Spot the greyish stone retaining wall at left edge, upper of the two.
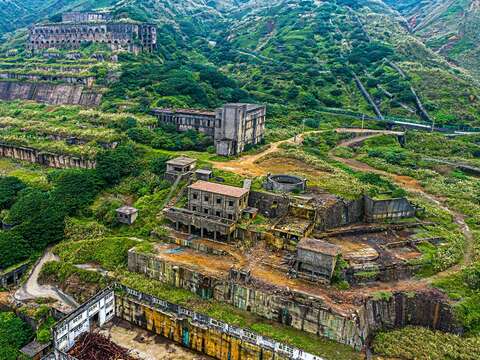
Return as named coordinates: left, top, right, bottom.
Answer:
left=0, top=80, right=102, bottom=107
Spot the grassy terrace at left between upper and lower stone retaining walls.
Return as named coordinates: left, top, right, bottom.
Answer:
left=0, top=101, right=156, bottom=158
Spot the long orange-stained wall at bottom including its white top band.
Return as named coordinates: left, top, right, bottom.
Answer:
left=115, top=287, right=322, bottom=360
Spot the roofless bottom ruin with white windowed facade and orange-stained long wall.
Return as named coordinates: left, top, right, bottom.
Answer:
left=46, top=284, right=322, bottom=360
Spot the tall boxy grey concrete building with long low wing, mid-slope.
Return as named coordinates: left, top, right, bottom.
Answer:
left=152, top=104, right=266, bottom=156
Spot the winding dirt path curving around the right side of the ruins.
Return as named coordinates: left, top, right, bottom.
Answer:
left=329, top=134, right=475, bottom=268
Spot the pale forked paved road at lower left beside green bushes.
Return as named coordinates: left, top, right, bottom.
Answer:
left=14, top=249, right=79, bottom=310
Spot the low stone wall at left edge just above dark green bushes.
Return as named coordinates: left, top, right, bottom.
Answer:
left=0, top=143, right=96, bottom=169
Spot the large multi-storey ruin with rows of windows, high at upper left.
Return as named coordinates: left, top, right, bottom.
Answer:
left=27, top=13, right=157, bottom=54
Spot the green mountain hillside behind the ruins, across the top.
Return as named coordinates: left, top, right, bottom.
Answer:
left=0, top=0, right=479, bottom=126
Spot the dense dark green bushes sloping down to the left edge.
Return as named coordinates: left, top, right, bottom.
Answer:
left=0, top=145, right=141, bottom=268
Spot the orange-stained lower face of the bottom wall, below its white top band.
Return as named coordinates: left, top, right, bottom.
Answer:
left=115, top=295, right=287, bottom=360
